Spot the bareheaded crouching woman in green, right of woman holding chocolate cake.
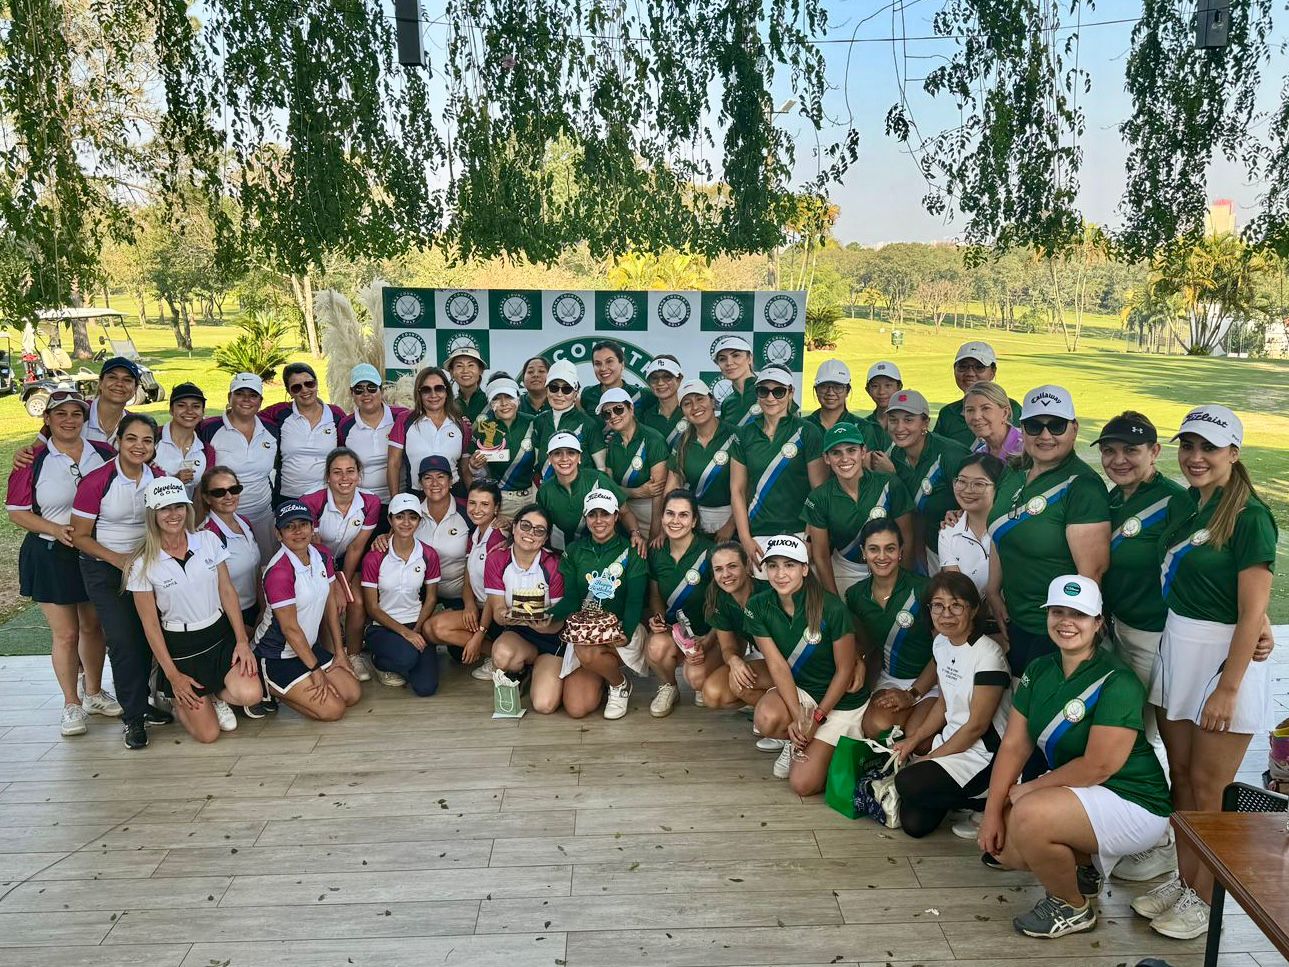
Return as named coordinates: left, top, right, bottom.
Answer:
left=645, top=490, right=721, bottom=718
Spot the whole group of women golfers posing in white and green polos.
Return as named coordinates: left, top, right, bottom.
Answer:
left=6, top=335, right=1276, bottom=937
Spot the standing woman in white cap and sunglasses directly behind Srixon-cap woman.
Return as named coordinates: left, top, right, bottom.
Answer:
left=730, top=366, right=828, bottom=565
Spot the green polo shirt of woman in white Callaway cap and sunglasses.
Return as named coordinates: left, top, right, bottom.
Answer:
left=989, top=453, right=1110, bottom=637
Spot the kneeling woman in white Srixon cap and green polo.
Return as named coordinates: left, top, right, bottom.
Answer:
left=746, top=534, right=867, bottom=796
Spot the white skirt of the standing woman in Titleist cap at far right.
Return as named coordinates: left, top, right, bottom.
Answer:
left=1150, top=611, right=1272, bottom=735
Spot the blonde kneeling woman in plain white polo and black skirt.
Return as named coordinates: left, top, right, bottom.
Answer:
left=125, top=477, right=260, bottom=743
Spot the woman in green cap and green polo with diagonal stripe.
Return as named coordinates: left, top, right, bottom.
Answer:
left=806, top=423, right=913, bottom=597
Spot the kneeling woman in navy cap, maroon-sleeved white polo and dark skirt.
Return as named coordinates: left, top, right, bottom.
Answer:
left=255, top=500, right=362, bottom=722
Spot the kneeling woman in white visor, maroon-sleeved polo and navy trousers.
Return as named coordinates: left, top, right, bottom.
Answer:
left=362, top=494, right=440, bottom=698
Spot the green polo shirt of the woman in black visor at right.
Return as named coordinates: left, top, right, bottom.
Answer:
left=1101, top=472, right=1186, bottom=632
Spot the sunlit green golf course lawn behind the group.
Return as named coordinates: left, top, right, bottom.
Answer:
left=0, top=318, right=1289, bottom=654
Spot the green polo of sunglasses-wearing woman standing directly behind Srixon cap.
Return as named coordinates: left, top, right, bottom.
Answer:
left=730, top=416, right=824, bottom=536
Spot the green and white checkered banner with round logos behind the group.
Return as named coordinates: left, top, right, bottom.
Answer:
left=384, top=286, right=806, bottom=400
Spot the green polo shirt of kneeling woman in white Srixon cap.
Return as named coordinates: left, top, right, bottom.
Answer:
left=745, top=589, right=869, bottom=712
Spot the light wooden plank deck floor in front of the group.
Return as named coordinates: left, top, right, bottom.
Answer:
left=0, top=636, right=1289, bottom=967
